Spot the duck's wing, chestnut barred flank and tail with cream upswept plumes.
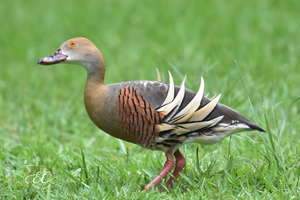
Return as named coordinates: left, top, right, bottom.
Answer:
left=110, top=74, right=265, bottom=151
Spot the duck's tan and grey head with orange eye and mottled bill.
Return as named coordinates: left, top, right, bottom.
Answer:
left=38, top=37, right=105, bottom=71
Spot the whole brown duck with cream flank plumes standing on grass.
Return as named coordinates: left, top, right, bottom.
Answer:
left=38, top=37, right=266, bottom=192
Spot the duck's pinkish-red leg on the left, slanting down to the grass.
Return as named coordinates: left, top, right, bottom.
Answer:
left=142, top=151, right=176, bottom=192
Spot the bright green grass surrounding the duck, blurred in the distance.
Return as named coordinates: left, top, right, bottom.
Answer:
left=0, top=0, right=300, bottom=199
